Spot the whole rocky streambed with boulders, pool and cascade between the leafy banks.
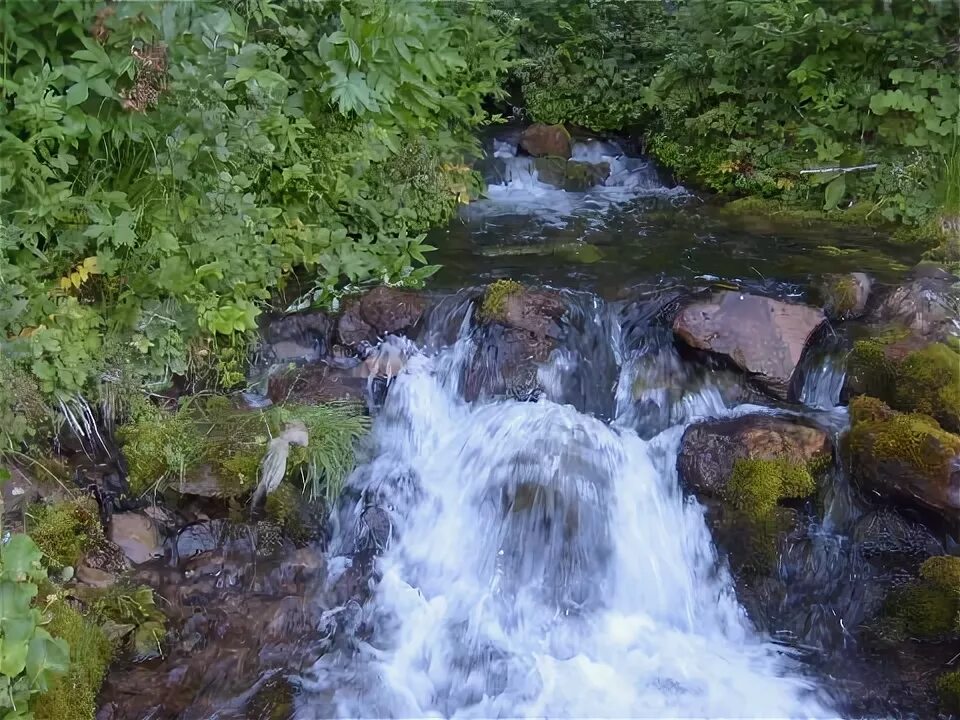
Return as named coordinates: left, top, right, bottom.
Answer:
left=4, top=126, right=960, bottom=720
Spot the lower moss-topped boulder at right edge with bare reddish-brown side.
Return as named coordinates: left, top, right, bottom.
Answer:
left=848, top=396, right=960, bottom=521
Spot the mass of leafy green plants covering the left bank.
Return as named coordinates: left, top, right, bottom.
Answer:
left=0, top=0, right=514, bottom=442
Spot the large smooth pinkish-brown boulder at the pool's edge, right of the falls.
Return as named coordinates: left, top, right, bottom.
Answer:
left=673, top=292, right=826, bottom=400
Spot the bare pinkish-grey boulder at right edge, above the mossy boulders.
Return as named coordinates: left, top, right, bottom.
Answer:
left=870, top=273, right=960, bottom=339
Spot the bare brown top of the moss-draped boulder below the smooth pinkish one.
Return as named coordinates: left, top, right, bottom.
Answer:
left=677, top=415, right=832, bottom=497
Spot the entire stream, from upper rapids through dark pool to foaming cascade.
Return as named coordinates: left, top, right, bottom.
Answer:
left=97, top=132, right=952, bottom=720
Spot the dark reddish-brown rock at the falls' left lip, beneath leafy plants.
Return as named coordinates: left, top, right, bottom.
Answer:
left=337, top=287, right=429, bottom=346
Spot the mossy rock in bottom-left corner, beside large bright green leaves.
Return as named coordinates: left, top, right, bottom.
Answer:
left=31, top=599, right=112, bottom=720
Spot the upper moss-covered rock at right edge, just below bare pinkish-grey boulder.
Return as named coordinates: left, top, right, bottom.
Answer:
left=850, top=335, right=960, bottom=432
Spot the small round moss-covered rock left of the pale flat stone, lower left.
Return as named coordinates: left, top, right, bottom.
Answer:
left=27, top=495, right=106, bottom=570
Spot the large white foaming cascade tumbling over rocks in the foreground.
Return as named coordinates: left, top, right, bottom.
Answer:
left=296, top=300, right=829, bottom=720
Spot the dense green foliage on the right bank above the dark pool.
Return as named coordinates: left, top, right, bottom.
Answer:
left=499, top=0, right=960, bottom=227
